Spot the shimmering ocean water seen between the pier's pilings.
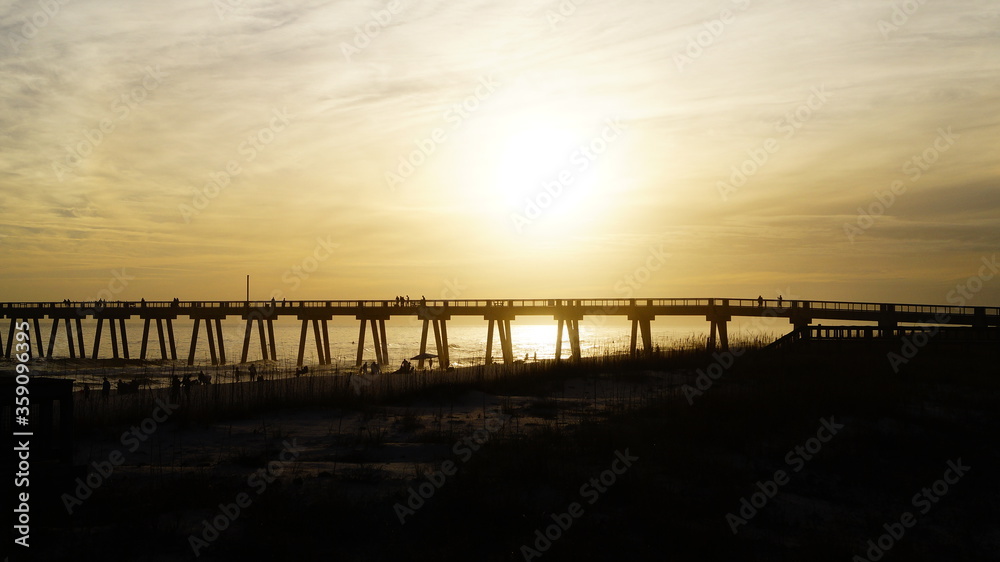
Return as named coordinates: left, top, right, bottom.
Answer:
left=2, top=318, right=708, bottom=367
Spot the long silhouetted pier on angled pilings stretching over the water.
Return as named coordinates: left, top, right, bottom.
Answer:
left=0, top=298, right=1000, bottom=368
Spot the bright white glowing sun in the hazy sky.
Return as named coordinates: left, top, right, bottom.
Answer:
left=452, top=101, right=628, bottom=241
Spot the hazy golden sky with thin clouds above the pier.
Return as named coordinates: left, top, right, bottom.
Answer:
left=0, top=0, right=1000, bottom=306
